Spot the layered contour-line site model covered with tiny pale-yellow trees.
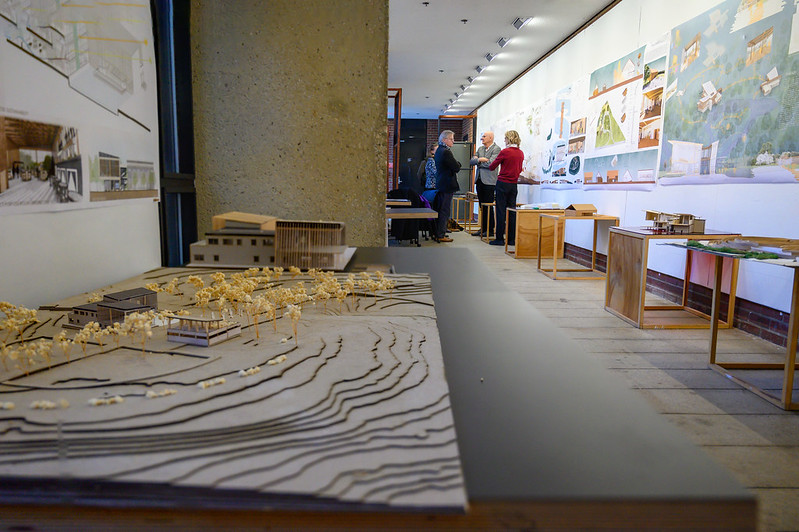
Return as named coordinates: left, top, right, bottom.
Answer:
left=0, top=267, right=467, bottom=512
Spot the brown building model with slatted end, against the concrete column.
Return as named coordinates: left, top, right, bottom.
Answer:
left=189, top=212, right=355, bottom=270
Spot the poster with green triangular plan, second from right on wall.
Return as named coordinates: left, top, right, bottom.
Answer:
left=583, top=35, right=668, bottom=190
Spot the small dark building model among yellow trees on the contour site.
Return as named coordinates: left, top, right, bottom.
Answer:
left=64, top=288, right=158, bottom=329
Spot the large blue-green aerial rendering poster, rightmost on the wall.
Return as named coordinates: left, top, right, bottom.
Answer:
left=658, top=0, right=799, bottom=185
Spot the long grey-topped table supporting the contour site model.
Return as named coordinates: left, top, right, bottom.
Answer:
left=0, top=247, right=756, bottom=530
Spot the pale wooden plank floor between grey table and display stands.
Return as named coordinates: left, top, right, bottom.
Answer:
left=389, top=232, right=799, bottom=531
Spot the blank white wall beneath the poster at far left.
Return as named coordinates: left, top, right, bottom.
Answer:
left=0, top=202, right=161, bottom=308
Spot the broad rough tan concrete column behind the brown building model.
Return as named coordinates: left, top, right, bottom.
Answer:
left=191, top=0, right=388, bottom=246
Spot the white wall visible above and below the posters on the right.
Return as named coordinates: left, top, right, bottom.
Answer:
left=476, top=0, right=799, bottom=311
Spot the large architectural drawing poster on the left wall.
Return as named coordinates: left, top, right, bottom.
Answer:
left=0, top=0, right=159, bottom=215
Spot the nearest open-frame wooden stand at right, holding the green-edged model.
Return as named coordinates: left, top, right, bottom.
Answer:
left=693, top=248, right=799, bottom=410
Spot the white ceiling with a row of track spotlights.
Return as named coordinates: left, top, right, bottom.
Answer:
left=388, top=0, right=616, bottom=118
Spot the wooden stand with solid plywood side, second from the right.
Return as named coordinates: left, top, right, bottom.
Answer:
left=605, top=227, right=740, bottom=329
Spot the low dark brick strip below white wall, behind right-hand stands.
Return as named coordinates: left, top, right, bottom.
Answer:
left=564, top=243, right=790, bottom=347
